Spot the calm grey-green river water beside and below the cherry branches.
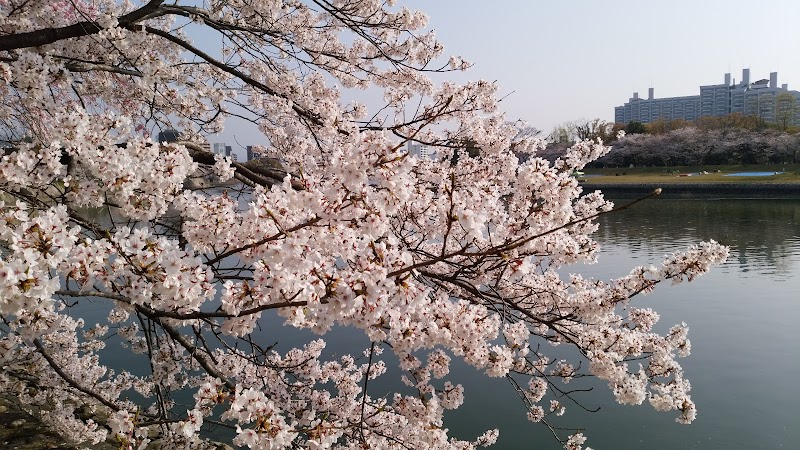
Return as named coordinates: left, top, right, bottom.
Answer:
left=450, top=199, right=800, bottom=450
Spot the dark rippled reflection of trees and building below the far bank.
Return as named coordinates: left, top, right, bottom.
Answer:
left=596, top=199, right=800, bottom=281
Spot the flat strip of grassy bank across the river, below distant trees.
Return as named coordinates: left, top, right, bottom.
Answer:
left=581, top=164, right=800, bottom=185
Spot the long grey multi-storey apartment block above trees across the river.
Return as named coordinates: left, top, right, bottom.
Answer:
left=614, top=69, right=800, bottom=125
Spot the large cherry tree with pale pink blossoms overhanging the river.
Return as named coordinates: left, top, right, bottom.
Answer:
left=0, top=0, right=727, bottom=449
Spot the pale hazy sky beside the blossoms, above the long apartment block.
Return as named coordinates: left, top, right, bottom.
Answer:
left=212, top=0, right=800, bottom=155
